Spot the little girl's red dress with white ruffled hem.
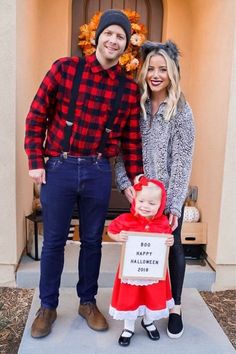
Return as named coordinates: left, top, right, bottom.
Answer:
left=108, top=183, right=174, bottom=320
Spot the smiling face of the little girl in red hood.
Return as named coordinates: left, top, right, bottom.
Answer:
left=135, top=187, right=161, bottom=219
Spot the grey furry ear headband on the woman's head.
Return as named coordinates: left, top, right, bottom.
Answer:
left=141, top=40, right=180, bottom=71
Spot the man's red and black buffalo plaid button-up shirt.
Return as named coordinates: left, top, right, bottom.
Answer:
left=25, top=55, right=143, bottom=183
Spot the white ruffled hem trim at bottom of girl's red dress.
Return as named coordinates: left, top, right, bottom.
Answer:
left=109, top=299, right=175, bottom=321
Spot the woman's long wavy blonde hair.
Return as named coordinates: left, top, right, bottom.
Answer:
left=137, top=49, right=181, bottom=121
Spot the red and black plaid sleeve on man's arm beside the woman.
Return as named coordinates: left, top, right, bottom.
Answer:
left=121, top=84, right=143, bottom=182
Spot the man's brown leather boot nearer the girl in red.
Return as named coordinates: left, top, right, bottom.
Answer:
left=79, top=302, right=108, bottom=331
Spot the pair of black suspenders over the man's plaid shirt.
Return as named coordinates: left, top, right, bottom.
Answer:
left=62, top=58, right=125, bottom=157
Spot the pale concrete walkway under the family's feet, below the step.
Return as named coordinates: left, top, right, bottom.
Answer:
left=18, top=288, right=235, bottom=354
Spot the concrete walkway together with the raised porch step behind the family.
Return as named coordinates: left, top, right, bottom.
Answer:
left=16, top=242, right=235, bottom=354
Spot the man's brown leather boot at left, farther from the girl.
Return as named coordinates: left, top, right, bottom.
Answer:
left=31, top=307, right=57, bottom=338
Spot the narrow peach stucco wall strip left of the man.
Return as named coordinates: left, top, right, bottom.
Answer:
left=16, top=0, right=39, bottom=272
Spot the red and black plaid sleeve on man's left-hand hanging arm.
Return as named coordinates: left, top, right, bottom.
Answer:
left=25, top=60, right=61, bottom=170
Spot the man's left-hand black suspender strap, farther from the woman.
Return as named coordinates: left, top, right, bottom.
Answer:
left=62, top=58, right=85, bottom=152
